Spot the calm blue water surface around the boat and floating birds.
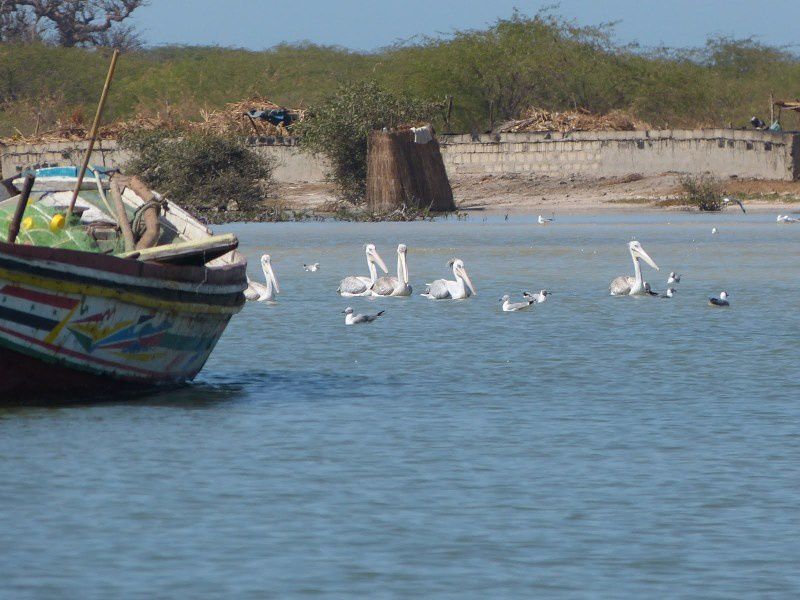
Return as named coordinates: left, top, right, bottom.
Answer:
left=0, top=213, right=800, bottom=599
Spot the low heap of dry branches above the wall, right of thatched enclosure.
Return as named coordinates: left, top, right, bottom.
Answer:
left=495, top=108, right=650, bottom=133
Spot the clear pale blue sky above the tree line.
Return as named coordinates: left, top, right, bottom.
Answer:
left=130, top=0, right=800, bottom=50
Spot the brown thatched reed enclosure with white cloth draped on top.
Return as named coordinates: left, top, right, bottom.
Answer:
left=367, top=129, right=456, bottom=213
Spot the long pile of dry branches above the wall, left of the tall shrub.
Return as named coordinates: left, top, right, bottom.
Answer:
left=0, top=97, right=305, bottom=144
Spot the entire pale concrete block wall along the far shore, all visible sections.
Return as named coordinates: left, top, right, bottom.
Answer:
left=0, top=129, right=800, bottom=183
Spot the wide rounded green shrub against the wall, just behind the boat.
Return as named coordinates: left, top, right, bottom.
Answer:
left=121, top=131, right=273, bottom=213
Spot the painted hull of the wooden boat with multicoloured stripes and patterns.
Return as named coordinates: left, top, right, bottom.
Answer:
left=0, top=243, right=247, bottom=403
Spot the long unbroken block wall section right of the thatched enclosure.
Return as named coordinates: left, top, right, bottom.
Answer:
left=440, top=129, right=800, bottom=180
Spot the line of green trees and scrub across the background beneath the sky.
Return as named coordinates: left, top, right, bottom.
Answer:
left=0, top=10, right=800, bottom=136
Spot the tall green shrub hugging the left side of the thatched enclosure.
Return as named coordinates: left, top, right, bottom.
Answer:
left=295, top=80, right=438, bottom=202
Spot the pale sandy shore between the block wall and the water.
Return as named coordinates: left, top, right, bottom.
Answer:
left=270, top=173, right=800, bottom=215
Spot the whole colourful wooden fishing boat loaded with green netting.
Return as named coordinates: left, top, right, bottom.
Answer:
left=0, top=167, right=247, bottom=401
